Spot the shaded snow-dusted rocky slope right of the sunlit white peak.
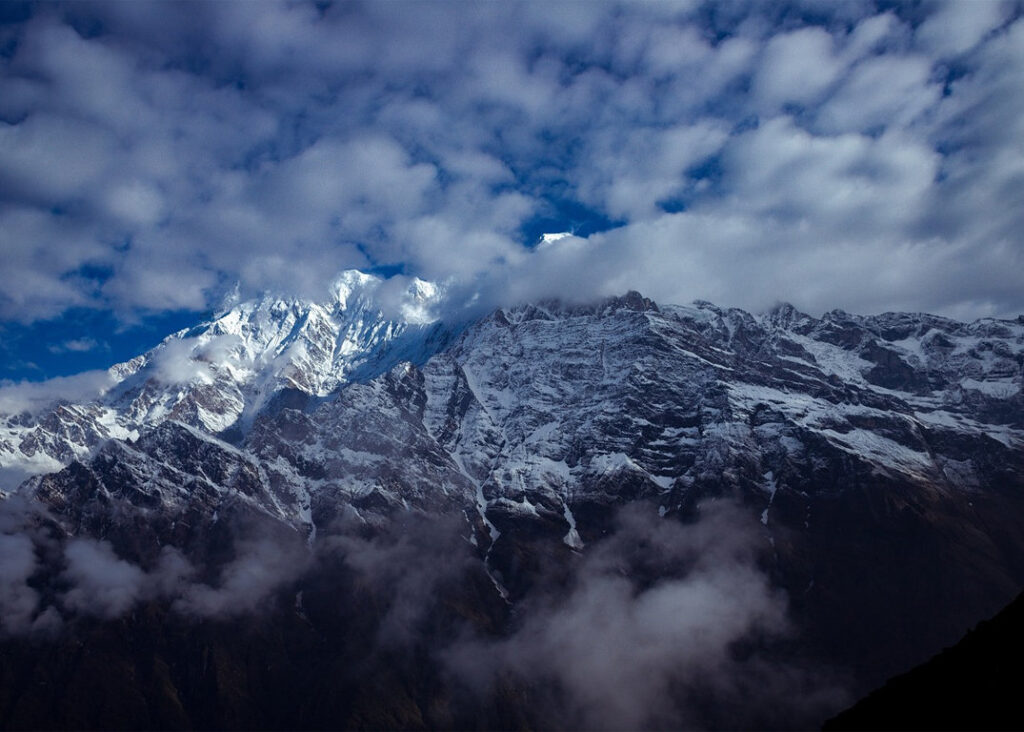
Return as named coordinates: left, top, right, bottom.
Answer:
left=249, top=295, right=1024, bottom=681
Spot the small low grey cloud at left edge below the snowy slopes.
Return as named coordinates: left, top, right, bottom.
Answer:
left=0, top=496, right=311, bottom=636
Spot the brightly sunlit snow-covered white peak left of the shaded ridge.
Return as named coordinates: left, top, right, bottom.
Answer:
left=0, top=269, right=455, bottom=487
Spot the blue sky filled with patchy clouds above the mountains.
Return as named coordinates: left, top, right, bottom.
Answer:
left=0, top=0, right=1024, bottom=381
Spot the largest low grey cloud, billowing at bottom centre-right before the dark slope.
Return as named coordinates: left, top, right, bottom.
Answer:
left=444, top=504, right=841, bottom=729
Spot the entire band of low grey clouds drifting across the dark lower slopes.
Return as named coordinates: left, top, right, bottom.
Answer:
left=0, top=489, right=846, bottom=729
